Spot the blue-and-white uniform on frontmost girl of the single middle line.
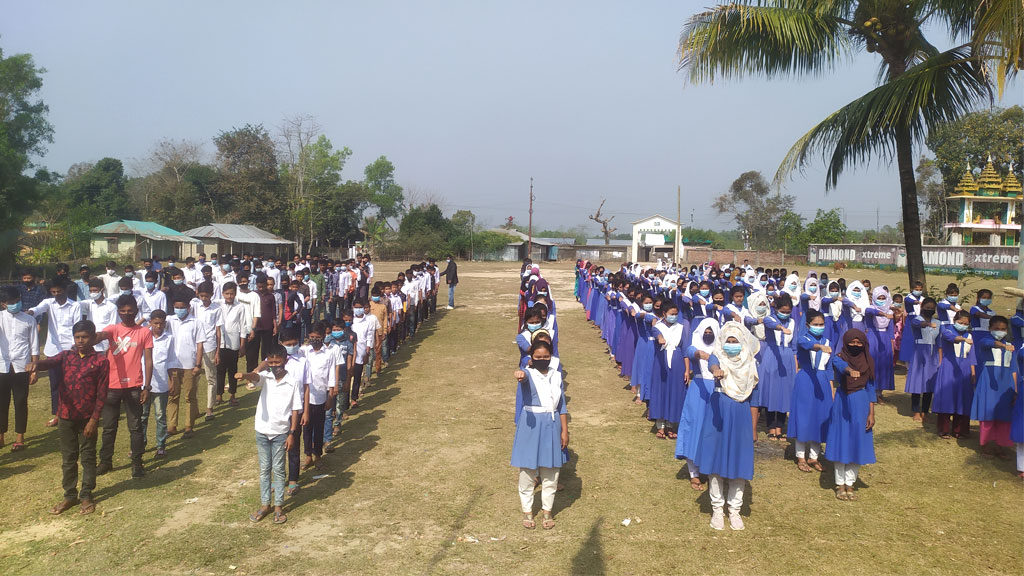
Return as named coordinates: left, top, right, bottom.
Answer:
left=510, top=368, right=568, bottom=469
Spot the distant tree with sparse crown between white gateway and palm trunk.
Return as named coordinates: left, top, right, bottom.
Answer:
left=714, top=171, right=797, bottom=250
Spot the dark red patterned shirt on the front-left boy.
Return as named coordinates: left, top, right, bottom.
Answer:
left=37, top=351, right=110, bottom=420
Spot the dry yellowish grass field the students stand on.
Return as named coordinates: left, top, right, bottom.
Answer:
left=0, top=263, right=1024, bottom=575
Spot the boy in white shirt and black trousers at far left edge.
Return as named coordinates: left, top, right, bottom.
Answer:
left=0, top=287, right=39, bottom=452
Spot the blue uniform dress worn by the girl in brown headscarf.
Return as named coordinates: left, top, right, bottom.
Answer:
left=825, top=356, right=876, bottom=465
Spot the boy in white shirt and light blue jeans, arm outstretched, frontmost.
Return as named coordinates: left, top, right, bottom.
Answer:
left=234, top=344, right=303, bottom=524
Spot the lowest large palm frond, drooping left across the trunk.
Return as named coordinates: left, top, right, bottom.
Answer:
left=775, top=46, right=992, bottom=190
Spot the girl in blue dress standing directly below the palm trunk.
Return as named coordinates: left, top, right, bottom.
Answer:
left=903, top=298, right=939, bottom=423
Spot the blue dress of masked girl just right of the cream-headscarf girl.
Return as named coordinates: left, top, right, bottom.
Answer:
left=758, top=313, right=797, bottom=412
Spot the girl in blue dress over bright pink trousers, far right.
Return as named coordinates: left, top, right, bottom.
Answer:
left=971, top=316, right=1017, bottom=458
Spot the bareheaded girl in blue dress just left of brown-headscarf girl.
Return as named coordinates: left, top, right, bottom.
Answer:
left=786, top=310, right=833, bottom=472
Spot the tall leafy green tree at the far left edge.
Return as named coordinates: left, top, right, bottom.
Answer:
left=0, top=49, right=53, bottom=271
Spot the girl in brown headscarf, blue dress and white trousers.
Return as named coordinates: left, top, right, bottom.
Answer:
left=825, top=328, right=874, bottom=500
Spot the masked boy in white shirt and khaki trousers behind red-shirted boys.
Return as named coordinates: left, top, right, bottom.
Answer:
left=167, top=294, right=206, bottom=438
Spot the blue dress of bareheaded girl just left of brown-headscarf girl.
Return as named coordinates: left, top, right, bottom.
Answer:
left=785, top=330, right=833, bottom=442
